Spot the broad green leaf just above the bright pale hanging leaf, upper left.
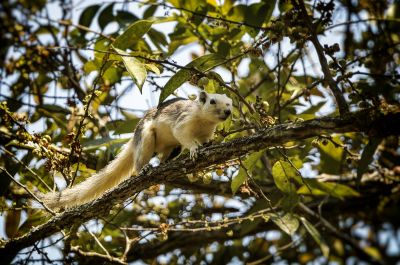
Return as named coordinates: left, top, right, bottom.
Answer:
left=113, top=20, right=153, bottom=50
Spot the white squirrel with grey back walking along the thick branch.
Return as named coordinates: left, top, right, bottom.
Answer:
left=41, top=91, right=232, bottom=209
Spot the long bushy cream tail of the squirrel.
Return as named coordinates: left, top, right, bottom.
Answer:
left=41, top=138, right=136, bottom=209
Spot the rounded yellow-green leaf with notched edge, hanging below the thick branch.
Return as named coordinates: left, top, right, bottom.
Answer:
left=272, top=160, right=298, bottom=193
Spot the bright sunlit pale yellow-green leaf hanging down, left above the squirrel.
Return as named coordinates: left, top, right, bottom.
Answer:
left=113, top=47, right=147, bottom=89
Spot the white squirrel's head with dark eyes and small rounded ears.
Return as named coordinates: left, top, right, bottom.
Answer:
left=199, top=91, right=232, bottom=122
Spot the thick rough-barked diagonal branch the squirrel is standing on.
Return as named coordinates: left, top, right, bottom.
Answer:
left=0, top=111, right=400, bottom=259
